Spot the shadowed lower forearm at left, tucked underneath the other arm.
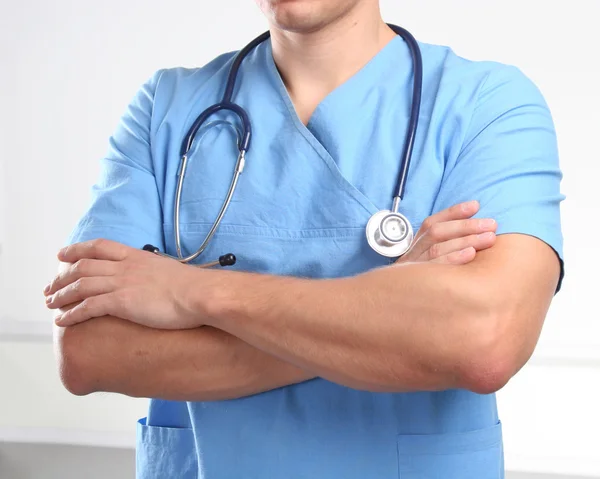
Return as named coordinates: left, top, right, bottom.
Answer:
left=55, top=317, right=313, bottom=401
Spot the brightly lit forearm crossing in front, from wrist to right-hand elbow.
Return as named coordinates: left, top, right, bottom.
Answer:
left=198, top=238, right=554, bottom=393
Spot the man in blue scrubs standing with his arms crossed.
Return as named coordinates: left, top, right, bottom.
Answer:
left=45, top=0, right=562, bottom=479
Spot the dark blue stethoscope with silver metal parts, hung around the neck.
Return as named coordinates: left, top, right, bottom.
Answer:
left=143, top=25, right=423, bottom=268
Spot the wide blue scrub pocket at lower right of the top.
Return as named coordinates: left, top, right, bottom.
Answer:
left=398, top=423, right=504, bottom=479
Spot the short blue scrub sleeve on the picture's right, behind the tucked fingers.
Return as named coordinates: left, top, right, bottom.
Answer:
left=434, top=66, right=564, bottom=288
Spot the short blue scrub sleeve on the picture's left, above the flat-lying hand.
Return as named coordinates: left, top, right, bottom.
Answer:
left=68, top=72, right=164, bottom=250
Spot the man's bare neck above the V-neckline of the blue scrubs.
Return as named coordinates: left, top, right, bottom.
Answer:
left=271, top=3, right=395, bottom=124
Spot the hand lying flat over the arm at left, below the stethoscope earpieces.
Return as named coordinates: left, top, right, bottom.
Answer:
left=44, top=240, right=205, bottom=329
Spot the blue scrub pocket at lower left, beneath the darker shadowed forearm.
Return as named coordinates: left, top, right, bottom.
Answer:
left=136, top=419, right=198, bottom=479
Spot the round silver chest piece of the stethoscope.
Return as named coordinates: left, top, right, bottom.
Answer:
left=366, top=210, right=413, bottom=258
